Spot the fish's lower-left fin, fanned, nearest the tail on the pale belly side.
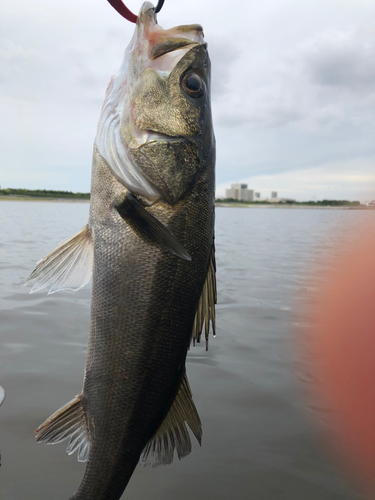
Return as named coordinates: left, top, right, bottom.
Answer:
left=35, top=395, right=90, bottom=462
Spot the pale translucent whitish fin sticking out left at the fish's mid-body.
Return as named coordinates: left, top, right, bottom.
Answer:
left=25, top=225, right=94, bottom=294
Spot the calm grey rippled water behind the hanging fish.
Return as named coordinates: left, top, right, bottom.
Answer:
left=0, top=201, right=374, bottom=500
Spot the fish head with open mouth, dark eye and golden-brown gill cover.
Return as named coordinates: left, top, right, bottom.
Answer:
left=96, top=2, right=215, bottom=204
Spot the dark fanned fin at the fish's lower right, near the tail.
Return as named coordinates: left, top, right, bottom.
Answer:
left=139, top=373, right=202, bottom=467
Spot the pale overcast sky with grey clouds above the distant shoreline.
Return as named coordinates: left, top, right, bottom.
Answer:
left=0, top=0, right=375, bottom=202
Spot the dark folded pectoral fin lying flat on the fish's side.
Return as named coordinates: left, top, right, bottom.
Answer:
left=116, top=194, right=191, bottom=260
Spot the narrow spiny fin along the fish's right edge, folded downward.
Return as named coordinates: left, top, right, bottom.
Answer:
left=191, top=245, right=217, bottom=351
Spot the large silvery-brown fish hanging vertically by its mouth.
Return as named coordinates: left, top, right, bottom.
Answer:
left=28, top=2, right=217, bottom=500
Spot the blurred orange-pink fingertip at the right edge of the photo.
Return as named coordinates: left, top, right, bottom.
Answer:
left=313, top=226, right=375, bottom=498
